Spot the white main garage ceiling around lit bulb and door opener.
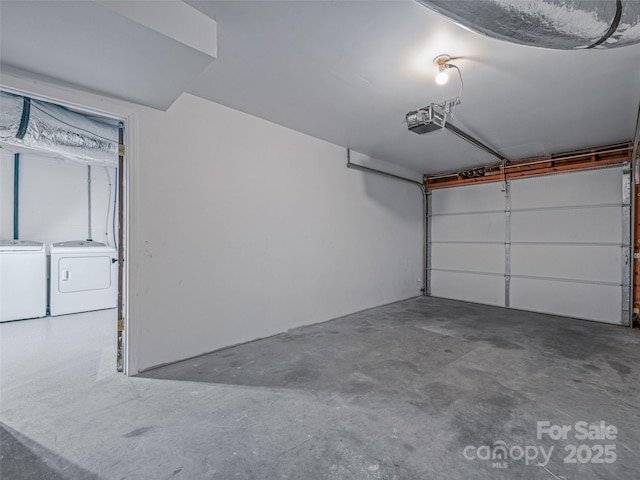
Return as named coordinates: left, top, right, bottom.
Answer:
left=0, top=0, right=640, bottom=173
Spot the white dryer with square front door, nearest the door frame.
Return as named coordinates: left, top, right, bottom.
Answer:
left=49, top=241, right=118, bottom=316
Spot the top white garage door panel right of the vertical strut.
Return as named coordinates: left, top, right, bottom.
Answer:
left=511, top=168, right=622, bottom=209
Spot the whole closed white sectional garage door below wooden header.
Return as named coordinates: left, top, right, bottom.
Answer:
left=428, top=165, right=631, bottom=324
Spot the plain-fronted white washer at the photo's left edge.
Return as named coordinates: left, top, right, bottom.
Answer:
left=0, top=240, right=47, bottom=322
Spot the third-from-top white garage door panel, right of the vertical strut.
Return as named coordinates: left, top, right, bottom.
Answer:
left=511, top=245, right=622, bottom=283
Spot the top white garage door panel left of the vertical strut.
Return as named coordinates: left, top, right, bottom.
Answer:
left=430, top=182, right=504, bottom=215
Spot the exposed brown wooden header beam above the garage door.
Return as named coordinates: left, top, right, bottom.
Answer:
left=424, top=142, right=633, bottom=190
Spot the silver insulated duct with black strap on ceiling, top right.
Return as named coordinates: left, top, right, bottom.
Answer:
left=416, top=0, right=640, bottom=50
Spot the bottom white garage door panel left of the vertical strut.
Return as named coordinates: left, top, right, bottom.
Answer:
left=431, top=270, right=504, bottom=306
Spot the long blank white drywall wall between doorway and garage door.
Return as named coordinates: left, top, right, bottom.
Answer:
left=131, top=94, right=423, bottom=370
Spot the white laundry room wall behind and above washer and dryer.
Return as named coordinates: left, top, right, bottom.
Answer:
left=0, top=149, right=115, bottom=249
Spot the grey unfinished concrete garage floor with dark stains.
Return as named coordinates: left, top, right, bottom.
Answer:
left=1, top=298, right=640, bottom=480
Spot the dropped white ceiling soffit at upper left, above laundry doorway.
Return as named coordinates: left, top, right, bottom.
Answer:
left=0, top=0, right=215, bottom=109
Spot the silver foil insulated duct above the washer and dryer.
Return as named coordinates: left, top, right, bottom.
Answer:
left=0, top=92, right=118, bottom=167
